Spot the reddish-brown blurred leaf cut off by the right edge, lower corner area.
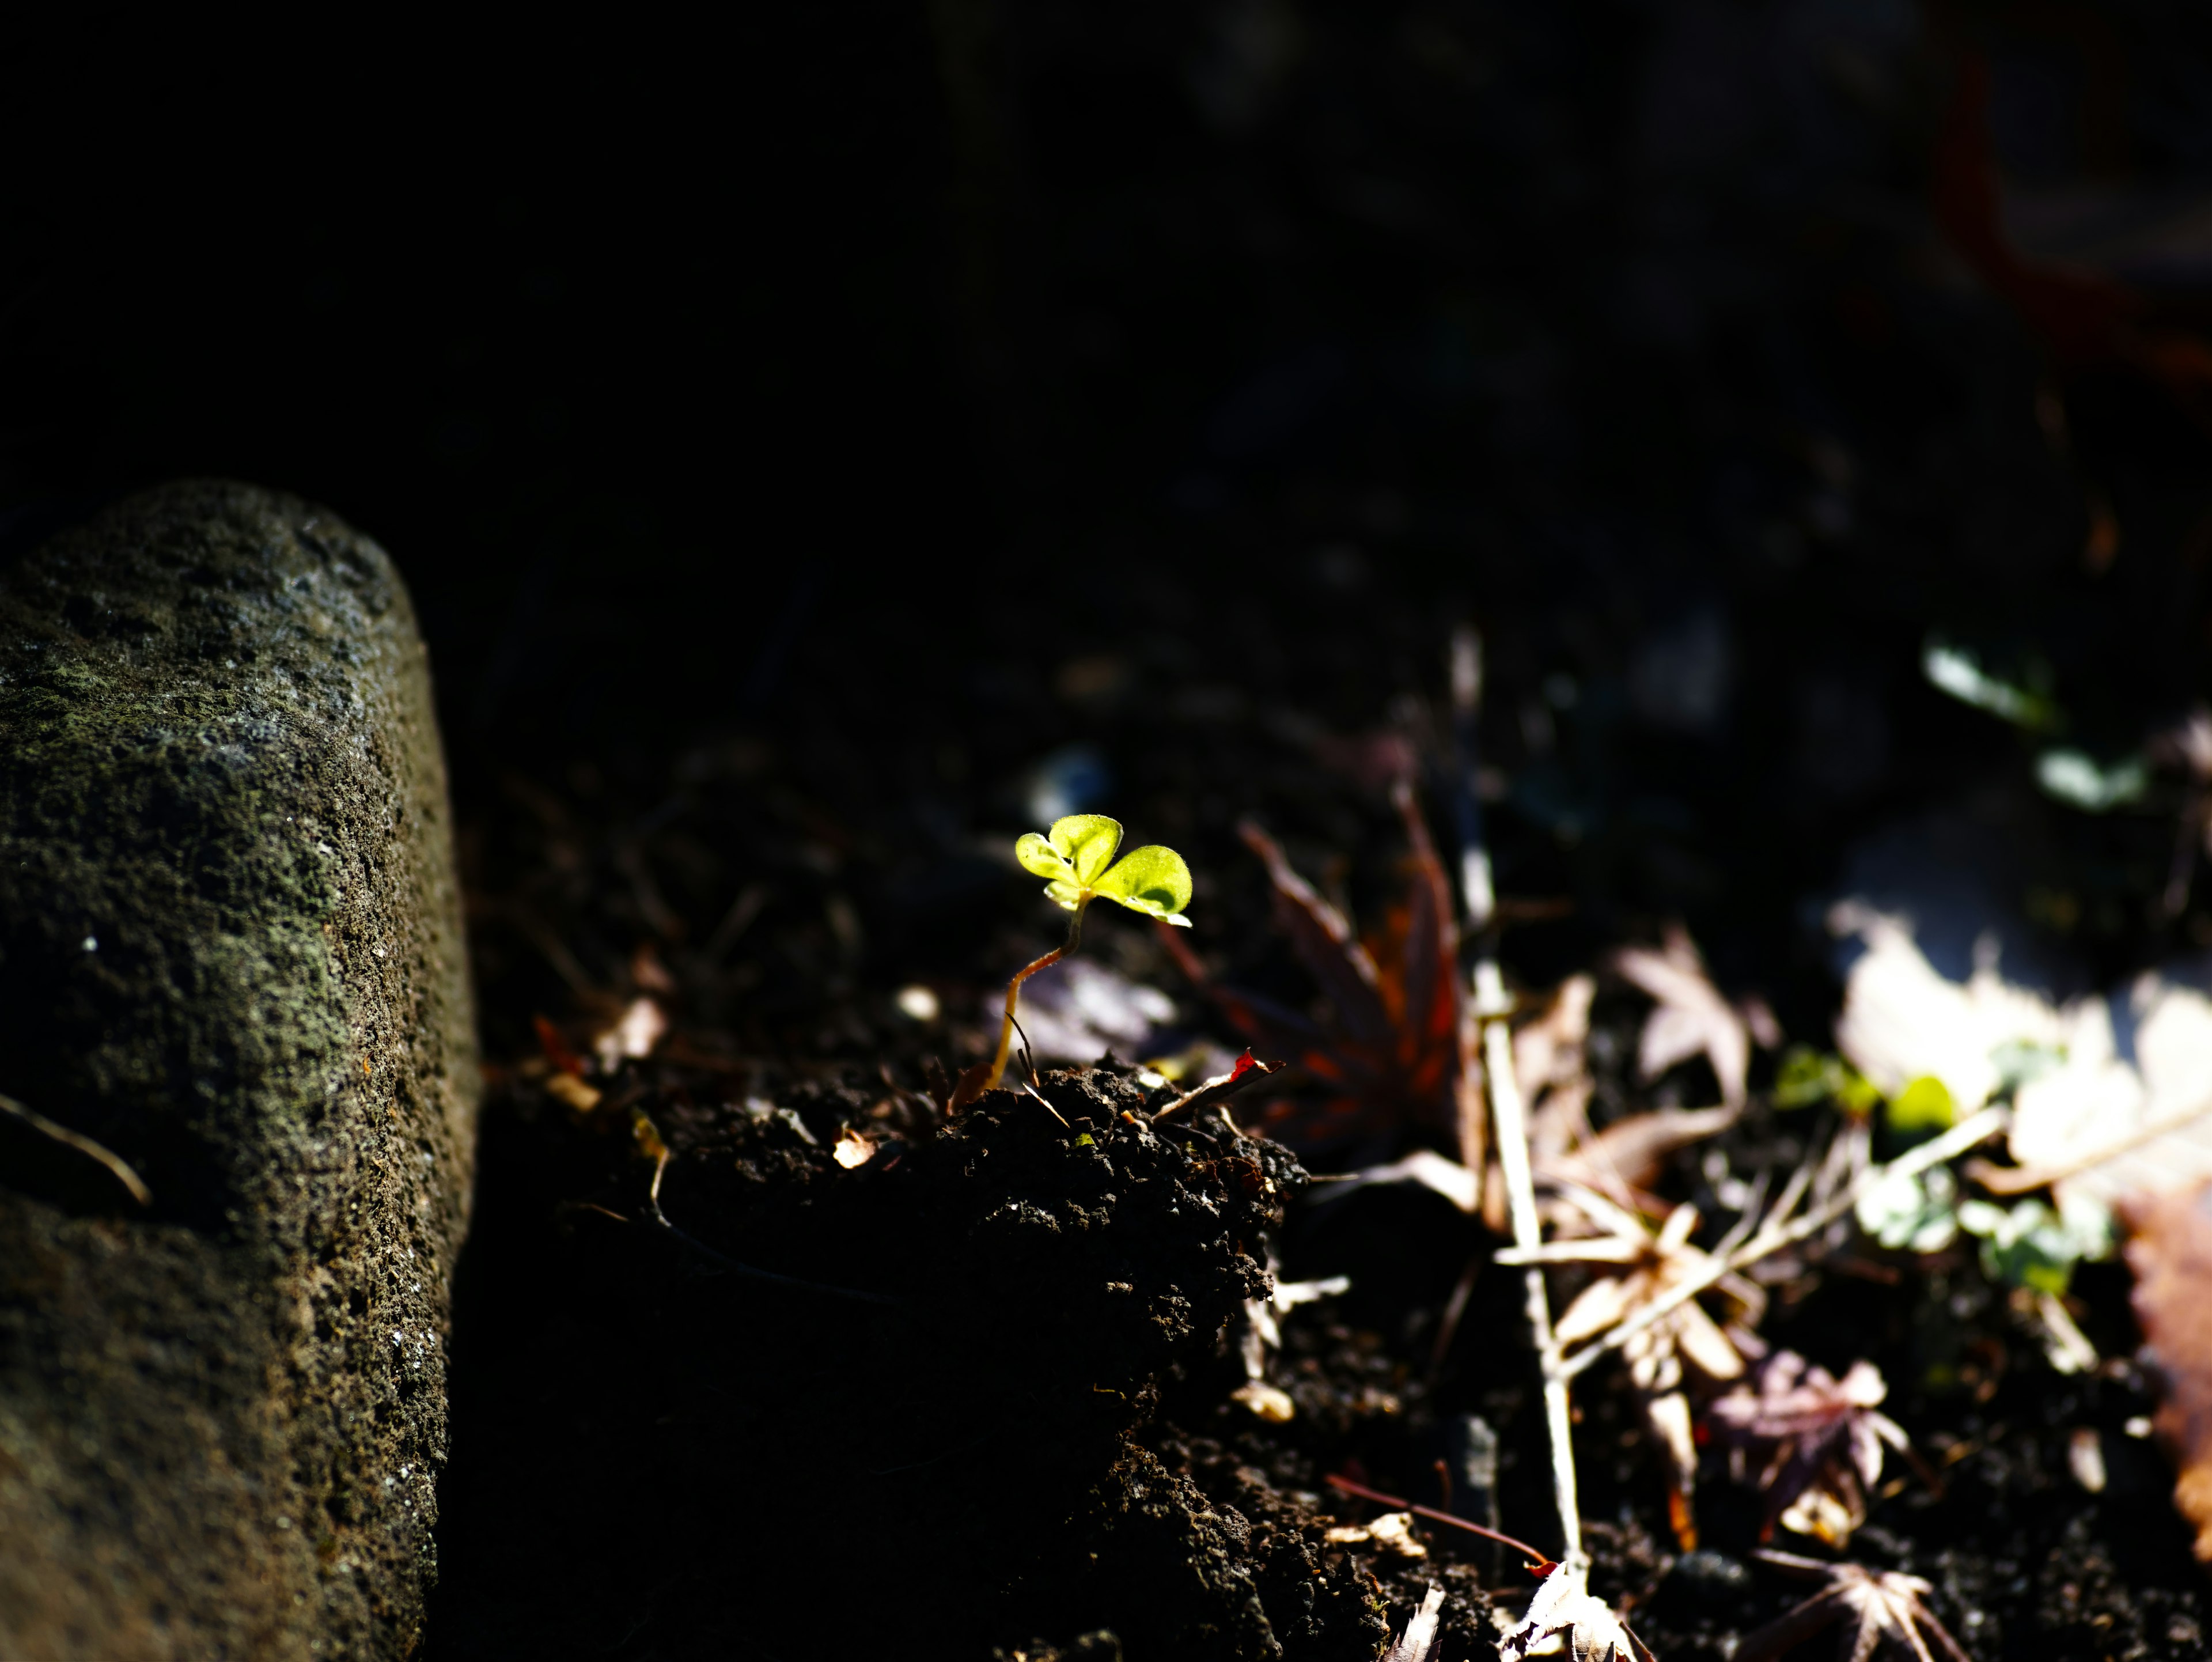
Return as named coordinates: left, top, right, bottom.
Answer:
left=2119, top=1184, right=2212, bottom=1562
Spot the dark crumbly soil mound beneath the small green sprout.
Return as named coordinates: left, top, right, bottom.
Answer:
left=422, top=1065, right=1460, bottom=1662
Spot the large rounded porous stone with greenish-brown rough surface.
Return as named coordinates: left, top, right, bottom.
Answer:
left=0, top=482, right=478, bottom=1662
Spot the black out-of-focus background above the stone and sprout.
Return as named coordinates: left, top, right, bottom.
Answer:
left=0, top=0, right=2212, bottom=1016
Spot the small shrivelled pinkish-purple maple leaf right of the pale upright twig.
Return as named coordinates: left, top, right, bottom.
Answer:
left=1707, top=1350, right=1909, bottom=1547
